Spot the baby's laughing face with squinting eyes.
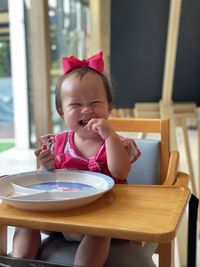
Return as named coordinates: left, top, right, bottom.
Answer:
left=59, top=72, right=112, bottom=137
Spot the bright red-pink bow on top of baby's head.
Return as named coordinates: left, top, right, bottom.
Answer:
left=62, top=51, right=104, bottom=74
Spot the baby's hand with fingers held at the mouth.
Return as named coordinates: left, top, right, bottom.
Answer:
left=86, top=118, right=115, bottom=140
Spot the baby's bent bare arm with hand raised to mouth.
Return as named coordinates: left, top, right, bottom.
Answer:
left=87, top=119, right=131, bottom=180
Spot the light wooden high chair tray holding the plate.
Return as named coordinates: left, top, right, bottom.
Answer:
left=0, top=185, right=190, bottom=264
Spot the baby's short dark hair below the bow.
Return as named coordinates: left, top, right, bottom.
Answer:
left=56, top=67, right=113, bottom=114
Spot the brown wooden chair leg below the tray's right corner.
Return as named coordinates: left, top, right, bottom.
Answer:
left=159, top=243, right=175, bottom=267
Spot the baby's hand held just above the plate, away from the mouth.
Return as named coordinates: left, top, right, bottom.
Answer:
left=35, top=145, right=55, bottom=170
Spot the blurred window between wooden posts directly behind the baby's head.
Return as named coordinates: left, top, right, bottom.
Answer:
left=48, top=0, right=90, bottom=132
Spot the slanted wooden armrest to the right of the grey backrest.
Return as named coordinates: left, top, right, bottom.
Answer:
left=164, top=151, right=179, bottom=186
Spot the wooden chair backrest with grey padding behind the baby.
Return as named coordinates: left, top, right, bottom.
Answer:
left=109, top=118, right=170, bottom=184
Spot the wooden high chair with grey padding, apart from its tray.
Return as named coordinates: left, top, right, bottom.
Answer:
left=38, top=118, right=188, bottom=267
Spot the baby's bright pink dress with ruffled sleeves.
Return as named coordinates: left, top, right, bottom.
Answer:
left=40, top=131, right=140, bottom=184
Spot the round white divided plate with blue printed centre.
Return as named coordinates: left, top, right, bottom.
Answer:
left=0, top=170, right=114, bottom=211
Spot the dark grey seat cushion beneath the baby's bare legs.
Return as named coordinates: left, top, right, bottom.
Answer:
left=37, top=233, right=157, bottom=267
